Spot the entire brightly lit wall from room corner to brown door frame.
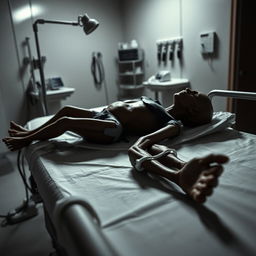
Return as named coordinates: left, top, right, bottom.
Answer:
left=123, top=0, right=231, bottom=111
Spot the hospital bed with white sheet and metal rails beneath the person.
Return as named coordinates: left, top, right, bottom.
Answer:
left=24, top=90, right=256, bottom=256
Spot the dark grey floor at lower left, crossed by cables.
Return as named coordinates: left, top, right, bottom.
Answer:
left=0, top=153, right=54, bottom=256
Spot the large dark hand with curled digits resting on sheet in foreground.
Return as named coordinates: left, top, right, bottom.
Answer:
left=179, top=154, right=228, bottom=203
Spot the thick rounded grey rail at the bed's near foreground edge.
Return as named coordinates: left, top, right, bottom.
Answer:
left=54, top=197, right=117, bottom=256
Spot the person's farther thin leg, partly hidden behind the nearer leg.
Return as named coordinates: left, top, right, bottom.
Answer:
left=8, top=106, right=93, bottom=137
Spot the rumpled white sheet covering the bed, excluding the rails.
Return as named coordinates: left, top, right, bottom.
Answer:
left=26, top=116, right=256, bottom=256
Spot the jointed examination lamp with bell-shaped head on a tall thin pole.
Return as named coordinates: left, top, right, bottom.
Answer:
left=33, top=14, right=99, bottom=115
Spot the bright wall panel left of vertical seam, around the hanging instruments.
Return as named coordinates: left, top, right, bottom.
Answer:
left=123, top=0, right=180, bottom=78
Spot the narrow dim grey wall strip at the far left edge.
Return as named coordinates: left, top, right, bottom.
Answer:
left=0, top=1, right=26, bottom=153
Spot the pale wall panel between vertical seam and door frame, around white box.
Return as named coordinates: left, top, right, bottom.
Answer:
left=182, top=0, right=231, bottom=111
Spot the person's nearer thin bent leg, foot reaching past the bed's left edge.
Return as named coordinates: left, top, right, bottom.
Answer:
left=3, top=117, right=116, bottom=150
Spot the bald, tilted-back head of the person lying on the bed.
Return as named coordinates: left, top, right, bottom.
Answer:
left=173, top=88, right=213, bottom=126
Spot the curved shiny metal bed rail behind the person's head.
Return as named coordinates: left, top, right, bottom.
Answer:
left=208, top=90, right=256, bottom=100
